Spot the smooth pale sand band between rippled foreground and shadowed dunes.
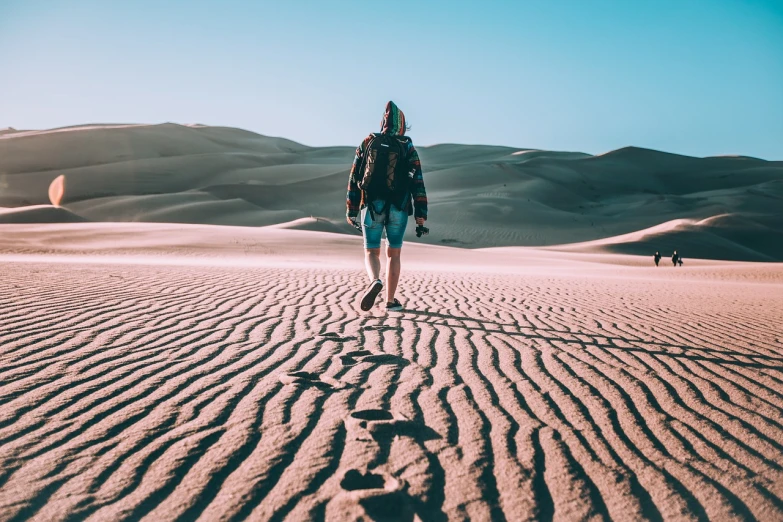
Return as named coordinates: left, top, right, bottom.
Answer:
left=6, top=218, right=779, bottom=276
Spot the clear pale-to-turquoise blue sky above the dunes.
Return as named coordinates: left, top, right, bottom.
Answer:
left=0, top=0, right=783, bottom=159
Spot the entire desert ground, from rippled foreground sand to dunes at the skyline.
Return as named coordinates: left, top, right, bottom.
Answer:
left=0, top=124, right=783, bottom=522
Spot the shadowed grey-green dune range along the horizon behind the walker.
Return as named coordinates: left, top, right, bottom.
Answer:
left=0, top=123, right=783, bottom=261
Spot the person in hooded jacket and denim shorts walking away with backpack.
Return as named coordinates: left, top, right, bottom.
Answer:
left=346, top=101, right=427, bottom=311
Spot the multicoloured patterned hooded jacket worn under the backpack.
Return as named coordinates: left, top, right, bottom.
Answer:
left=345, top=101, right=427, bottom=219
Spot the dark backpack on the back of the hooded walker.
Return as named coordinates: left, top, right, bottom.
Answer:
left=357, top=134, right=410, bottom=213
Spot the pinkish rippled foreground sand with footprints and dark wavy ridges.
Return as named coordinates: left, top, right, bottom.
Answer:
left=0, top=263, right=783, bottom=521
